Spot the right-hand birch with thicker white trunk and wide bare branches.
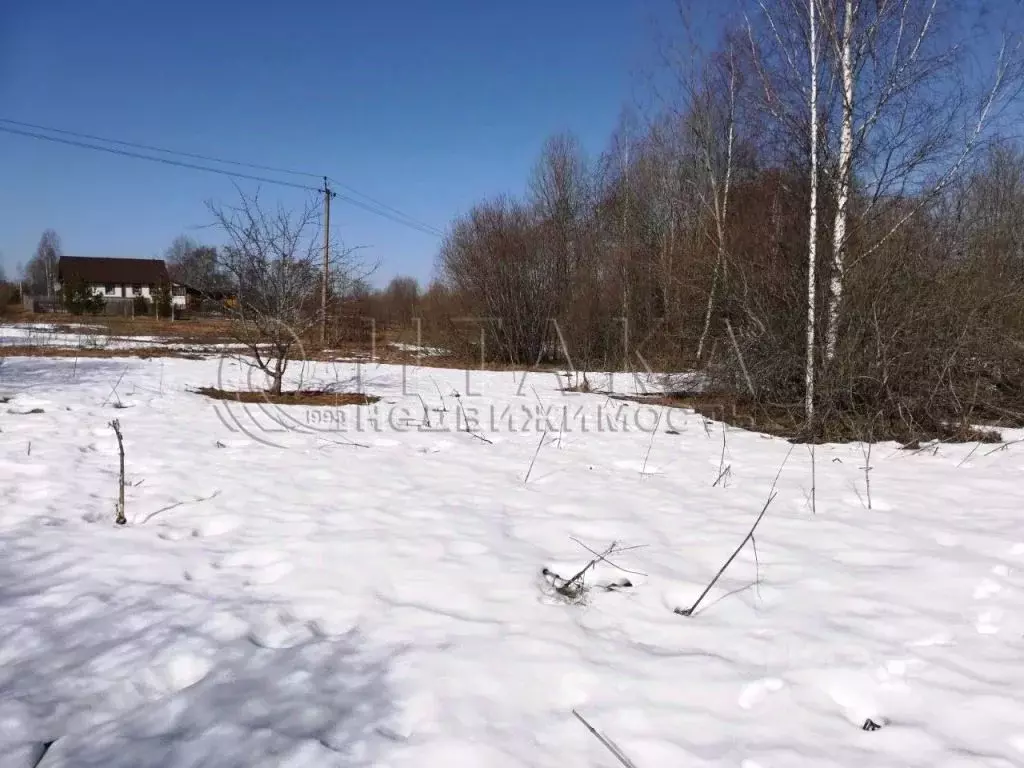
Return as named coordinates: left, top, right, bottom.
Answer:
left=815, top=0, right=1024, bottom=361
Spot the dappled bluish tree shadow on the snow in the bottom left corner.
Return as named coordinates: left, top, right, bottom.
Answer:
left=0, top=530, right=393, bottom=768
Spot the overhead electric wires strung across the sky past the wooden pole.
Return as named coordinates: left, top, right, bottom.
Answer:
left=0, top=118, right=443, bottom=238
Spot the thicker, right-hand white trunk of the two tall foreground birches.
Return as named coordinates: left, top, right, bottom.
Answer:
left=825, top=0, right=855, bottom=361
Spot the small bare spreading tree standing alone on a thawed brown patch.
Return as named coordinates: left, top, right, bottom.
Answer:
left=209, top=190, right=364, bottom=394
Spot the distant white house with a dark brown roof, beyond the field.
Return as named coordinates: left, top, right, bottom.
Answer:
left=55, top=256, right=187, bottom=307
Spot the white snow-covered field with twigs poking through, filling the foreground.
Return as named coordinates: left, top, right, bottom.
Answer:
left=0, top=358, right=1024, bottom=768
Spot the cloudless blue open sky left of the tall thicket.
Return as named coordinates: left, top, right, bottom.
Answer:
left=0, top=0, right=658, bottom=283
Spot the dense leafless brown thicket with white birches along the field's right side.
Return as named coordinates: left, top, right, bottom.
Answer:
left=385, top=0, right=1024, bottom=439
